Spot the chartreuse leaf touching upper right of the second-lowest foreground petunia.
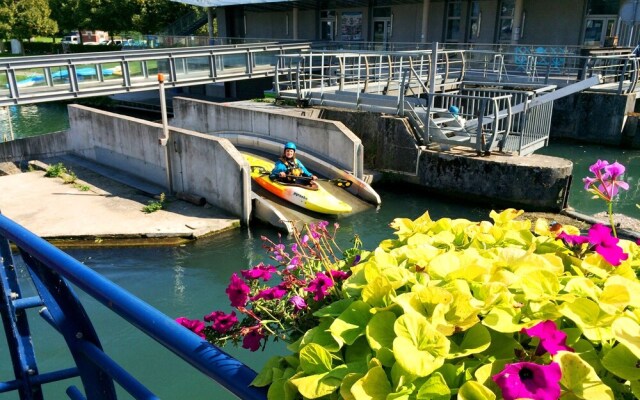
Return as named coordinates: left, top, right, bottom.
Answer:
left=560, top=298, right=615, bottom=341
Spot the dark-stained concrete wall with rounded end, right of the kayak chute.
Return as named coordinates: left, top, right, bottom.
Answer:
left=321, top=109, right=573, bottom=211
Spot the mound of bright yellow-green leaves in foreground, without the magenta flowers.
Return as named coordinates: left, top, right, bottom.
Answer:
left=242, top=209, right=640, bottom=399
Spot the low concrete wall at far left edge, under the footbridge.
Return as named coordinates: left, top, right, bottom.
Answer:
left=0, top=131, right=68, bottom=162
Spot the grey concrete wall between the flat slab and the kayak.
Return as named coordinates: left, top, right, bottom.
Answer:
left=68, top=105, right=251, bottom=224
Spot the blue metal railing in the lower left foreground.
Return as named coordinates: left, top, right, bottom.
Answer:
left=0, top=214, right=266, bottom=400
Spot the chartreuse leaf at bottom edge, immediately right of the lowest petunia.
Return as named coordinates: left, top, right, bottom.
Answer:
left=553, top=351, right=614, bottom=400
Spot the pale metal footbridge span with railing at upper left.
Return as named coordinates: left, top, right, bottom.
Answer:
left=0, top=43, right=309, bottom=106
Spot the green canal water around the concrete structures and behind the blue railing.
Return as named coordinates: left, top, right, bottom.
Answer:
left=0, top=104, right=640, bottom=400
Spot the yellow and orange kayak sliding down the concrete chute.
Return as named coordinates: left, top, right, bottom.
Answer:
left=243, top=154, right=351, bottom=214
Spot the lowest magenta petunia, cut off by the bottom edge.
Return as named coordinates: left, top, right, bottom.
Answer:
left=493, top=362, right=562, bottom=400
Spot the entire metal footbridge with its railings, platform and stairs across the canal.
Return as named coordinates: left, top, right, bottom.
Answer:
left=6, top=42, right=640, bottom=155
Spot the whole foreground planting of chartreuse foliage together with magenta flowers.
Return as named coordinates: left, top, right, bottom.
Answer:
left=178, top=209, right=640, bottom=400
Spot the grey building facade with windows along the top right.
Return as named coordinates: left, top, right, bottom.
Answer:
left=188, top=0, right=640, bottom=47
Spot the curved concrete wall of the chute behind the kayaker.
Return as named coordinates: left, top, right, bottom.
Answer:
left=171, top=97, right=363, bottom=178
